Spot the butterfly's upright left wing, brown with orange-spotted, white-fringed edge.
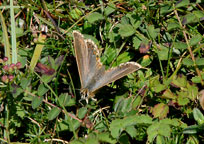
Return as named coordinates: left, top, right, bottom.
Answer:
left=73, top=31, right=105, bottom=90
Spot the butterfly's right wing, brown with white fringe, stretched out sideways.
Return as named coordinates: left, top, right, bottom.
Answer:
left=90, top=62, right=141, bottom=92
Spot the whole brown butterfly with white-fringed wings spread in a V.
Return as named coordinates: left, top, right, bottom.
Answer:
left=73, top=31, right=142, bottom=101
